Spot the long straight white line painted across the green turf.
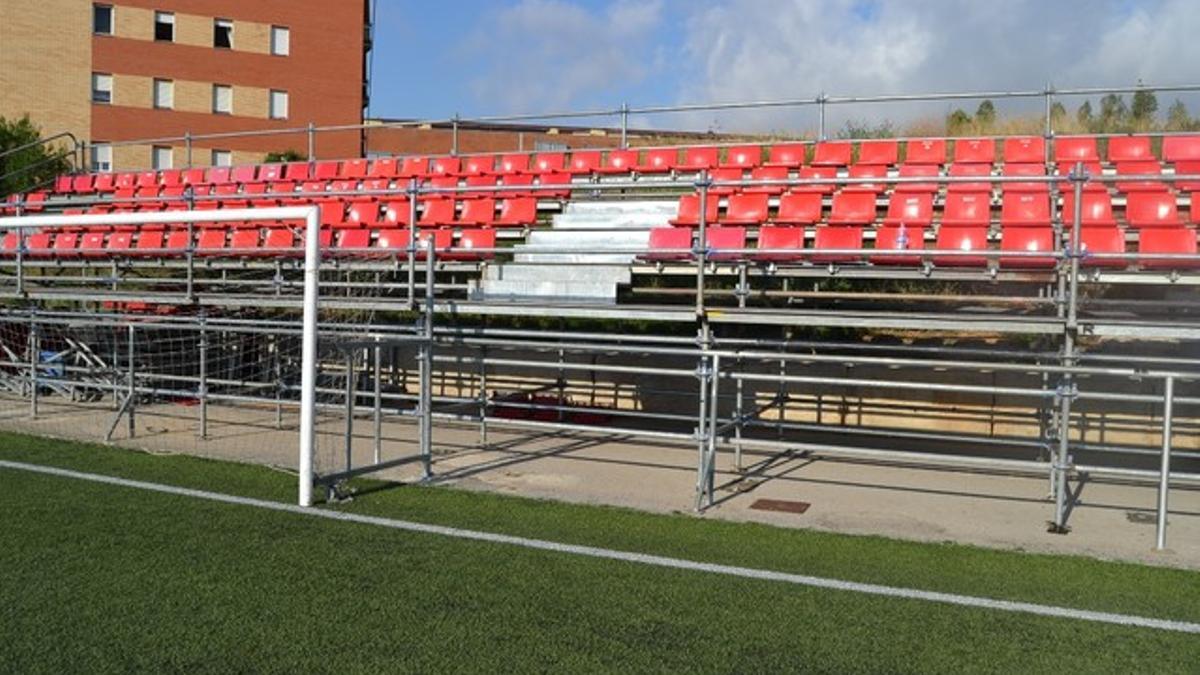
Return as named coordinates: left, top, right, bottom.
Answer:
left=0, top=460, right=1200, bottom=634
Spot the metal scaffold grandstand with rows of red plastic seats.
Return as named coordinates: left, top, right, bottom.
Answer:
left=0, top=86, right=1200, bottom=545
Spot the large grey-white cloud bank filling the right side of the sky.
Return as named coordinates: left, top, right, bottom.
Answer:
left=677, top=0, right=1200, bottom=130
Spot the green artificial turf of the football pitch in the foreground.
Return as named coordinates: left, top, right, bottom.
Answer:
left=0, top=434, right=1200, bottom=673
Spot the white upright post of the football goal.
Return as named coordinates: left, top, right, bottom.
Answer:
left=299, top=207, right=320, bottom=507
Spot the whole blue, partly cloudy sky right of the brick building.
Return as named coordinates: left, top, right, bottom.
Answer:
left=370, top=0, right=1200, bottom=131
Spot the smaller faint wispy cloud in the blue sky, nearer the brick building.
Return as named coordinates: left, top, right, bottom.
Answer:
left=467, top=0, right=662, bottom=112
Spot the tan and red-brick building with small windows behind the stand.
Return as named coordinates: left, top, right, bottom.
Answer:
left=0, top=0, right=370, bottom=171
